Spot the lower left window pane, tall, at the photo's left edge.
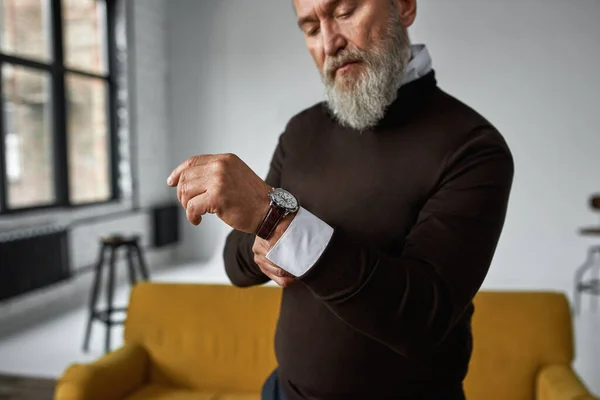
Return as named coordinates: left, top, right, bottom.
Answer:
left=2, top=64, right=55, bottom=209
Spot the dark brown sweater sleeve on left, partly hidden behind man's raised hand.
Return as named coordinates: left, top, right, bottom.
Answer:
left=223, top=136, right=284, bottom=287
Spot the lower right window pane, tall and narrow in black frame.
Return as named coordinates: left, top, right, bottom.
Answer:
left=66, top=74, right=111, bottom=204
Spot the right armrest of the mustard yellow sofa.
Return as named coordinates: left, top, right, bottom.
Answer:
left=536, top=365, right=597, bottom=400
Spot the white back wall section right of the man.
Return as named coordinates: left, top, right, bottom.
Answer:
left=413, top=0, right=600, bottom=290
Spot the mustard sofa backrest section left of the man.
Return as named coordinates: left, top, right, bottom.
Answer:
left=125, top=283, right=281, bottom=392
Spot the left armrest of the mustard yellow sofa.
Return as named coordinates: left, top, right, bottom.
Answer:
left=54, top=343, right=149, bottom=400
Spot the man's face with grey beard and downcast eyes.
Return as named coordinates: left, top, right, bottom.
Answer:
left=294, top=0, right=416, bottom=129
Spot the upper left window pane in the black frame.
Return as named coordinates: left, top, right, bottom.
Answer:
left=0, top=0, right=51, bottom=61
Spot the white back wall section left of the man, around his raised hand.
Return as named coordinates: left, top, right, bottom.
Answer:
left=168, top=0, right=321, bottom=259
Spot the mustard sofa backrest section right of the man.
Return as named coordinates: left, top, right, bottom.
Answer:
left=465, top=291, right=573, bottom=400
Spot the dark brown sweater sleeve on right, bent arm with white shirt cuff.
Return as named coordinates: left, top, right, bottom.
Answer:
left=300, top=128, right=514, bottom=358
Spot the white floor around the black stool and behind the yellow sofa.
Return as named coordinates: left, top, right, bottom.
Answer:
left=0, top=261, right=600, bottom=400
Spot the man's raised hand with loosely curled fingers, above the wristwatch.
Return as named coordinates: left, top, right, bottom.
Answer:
left=167, top=154, right=271, bottom=233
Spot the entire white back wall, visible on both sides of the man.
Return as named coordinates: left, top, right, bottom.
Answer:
left=168, top=0, right=600, bottom=392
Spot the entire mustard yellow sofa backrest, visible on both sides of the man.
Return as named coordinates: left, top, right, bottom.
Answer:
left=125, top=283, right=573, bottom=400
